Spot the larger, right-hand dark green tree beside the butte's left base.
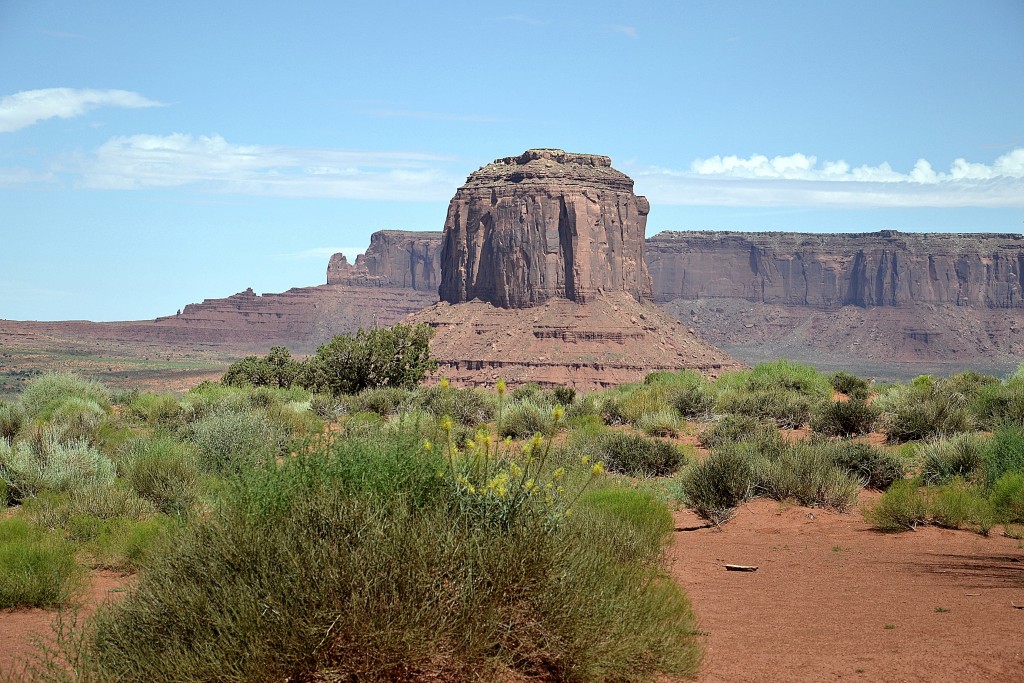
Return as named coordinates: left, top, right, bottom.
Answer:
left=300, top=324, right=437, bottom=395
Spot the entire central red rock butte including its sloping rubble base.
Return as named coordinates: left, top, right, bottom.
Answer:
left=408, top=150, right=743, bottom=389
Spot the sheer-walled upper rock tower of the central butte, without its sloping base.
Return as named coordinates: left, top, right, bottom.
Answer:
left=439, top=150, right=651, bottom=308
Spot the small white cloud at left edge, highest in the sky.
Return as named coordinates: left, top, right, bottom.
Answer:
left=0, top=88, right=163, bottom=133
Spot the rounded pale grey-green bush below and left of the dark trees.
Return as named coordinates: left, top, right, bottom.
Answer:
left=188, top=411, right=284, bottom=473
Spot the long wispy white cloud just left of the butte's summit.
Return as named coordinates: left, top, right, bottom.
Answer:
left=74, top=133, right=464, bottom=201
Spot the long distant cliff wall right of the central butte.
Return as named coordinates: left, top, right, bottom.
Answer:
left=647, top=230, right=1024, bottom=310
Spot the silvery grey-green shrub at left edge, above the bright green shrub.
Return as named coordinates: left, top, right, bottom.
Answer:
left=0, top=430, right=116, bottom=503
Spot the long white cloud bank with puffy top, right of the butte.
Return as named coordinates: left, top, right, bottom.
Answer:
left=634, top=148, right=1024, bottom=207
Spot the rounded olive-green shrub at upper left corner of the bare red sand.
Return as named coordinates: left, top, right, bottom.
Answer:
left=680, top=447, right=755, bottom=524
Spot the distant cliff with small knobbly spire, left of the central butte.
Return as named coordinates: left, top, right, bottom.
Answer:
left=327, top=230, right=441, bottom=294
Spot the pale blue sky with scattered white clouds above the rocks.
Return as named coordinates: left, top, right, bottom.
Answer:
left=0, top=0, right=1024, bottom=321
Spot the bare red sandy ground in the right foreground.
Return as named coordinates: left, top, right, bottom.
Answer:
left=669, top=494, right=1024, bottom=683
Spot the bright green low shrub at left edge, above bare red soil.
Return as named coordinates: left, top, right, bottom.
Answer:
left=0, top=517, right=82, bottom=608
